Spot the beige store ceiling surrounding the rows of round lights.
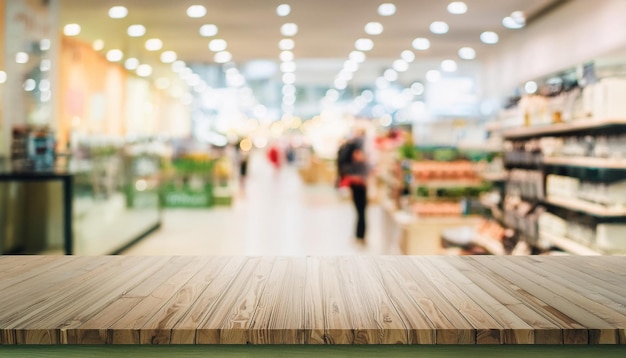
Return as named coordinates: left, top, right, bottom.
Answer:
left=61, top=0, right=563, bottom=92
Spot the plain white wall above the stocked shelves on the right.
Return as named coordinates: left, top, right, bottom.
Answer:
left=483, top=0, right=626, bottom=98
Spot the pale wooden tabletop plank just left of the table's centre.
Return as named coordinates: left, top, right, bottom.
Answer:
left=250, top=257, right=309, bottom=344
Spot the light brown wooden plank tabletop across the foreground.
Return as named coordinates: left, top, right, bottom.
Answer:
left=0, top=256, right=626, bottom=344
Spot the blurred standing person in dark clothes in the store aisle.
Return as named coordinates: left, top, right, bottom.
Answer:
left=341, top=146, right=370, bottom=242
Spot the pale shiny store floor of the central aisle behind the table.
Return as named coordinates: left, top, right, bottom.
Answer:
left=123, top=153, right=392, bottom=256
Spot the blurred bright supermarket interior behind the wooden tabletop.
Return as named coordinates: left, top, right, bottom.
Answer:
left=0, top=0, right=626, bottom=255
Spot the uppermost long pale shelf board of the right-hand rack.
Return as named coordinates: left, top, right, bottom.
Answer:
left=503, top=119, right=626, bottom=139
